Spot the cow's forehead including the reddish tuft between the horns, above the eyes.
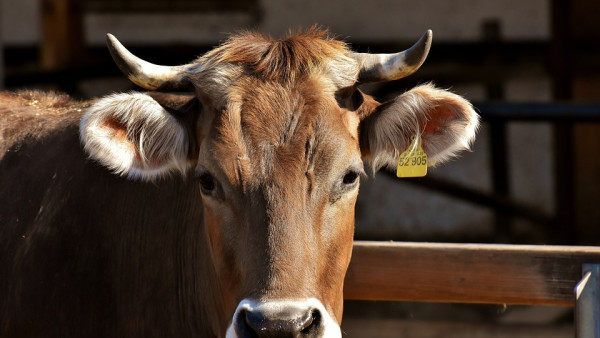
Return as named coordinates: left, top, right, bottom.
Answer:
left=193, top=30, right=360, bottom=189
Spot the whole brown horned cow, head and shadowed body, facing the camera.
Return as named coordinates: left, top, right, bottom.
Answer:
left=0, top=27, right=479, bottom=337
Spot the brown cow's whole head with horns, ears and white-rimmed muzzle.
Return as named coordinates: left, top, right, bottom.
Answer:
left=81, top=29, right=478, bottom=337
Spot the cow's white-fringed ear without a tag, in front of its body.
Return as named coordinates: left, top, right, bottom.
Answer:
left=79, top=93, right=199, bottom=180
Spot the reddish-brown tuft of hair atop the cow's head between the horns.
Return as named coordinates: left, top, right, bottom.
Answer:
left=206, top=25, right=359, bottom=81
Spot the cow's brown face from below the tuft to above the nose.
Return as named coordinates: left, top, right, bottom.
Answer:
left=196, top=79, right=363, bottom=325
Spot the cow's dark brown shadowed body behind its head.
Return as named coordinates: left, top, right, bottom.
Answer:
left=0, top=92, right=227, bottom=337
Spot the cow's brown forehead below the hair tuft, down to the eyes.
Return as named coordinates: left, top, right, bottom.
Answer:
left=205, top=77, right=359, bottom=187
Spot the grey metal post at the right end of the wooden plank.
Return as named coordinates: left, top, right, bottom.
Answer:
left=575, top=264, right=600, bottom=338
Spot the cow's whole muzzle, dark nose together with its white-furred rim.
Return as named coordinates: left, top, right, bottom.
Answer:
left=227, top=299, right=341, bottom=338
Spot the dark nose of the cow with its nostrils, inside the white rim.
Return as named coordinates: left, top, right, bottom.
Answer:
left=239, top=305, right=321, bottom=338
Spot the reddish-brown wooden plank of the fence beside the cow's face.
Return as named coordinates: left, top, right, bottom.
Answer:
left=344, top=241, right=600, bottom=306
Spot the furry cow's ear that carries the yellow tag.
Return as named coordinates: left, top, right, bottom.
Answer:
left=360, top=84, right=479, bottom=172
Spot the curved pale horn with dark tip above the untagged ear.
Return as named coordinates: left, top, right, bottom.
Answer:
left=106, top=34, right=191, bottom=90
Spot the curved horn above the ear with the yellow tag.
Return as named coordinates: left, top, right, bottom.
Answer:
left=354, top=30, right=433, bottom=83
